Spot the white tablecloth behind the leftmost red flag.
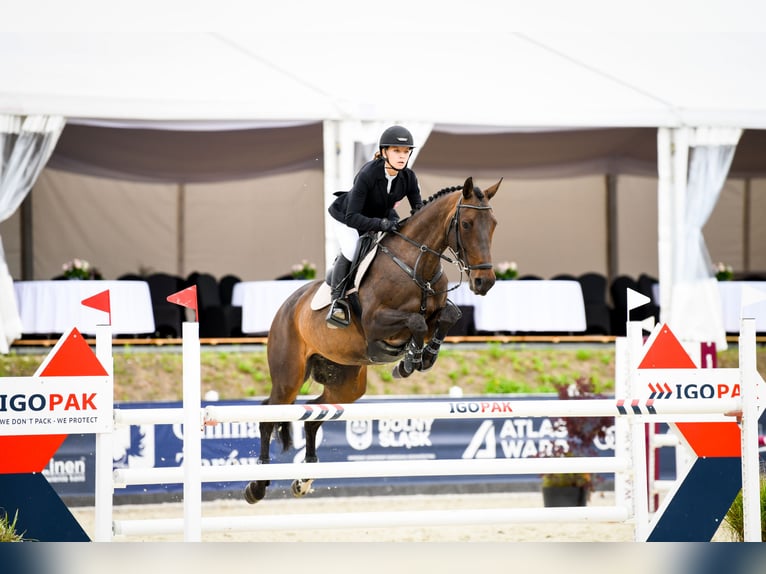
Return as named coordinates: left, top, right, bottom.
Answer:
left=13, top=280, right=154, bottom=335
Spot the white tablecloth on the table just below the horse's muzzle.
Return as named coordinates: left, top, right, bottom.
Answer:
left=448, top=280, right=586, bottom=333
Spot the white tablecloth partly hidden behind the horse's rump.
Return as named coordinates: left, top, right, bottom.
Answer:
left=231, top=280, right=310, bottom=333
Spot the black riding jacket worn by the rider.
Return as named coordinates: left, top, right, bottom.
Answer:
left=328, top=158, right=423, bottom=235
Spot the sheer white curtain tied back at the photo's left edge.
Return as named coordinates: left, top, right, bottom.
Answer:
left=0, top=115, right=65, bottom=354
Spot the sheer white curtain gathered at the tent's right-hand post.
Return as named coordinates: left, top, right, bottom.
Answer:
left=670, top=130, right=741, bottom=350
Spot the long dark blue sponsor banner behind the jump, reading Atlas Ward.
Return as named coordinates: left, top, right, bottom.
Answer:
left=45, top=395, right=632, bottom=497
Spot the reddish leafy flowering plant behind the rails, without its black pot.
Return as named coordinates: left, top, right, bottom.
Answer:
left=542, top=377, right=613, bottom=491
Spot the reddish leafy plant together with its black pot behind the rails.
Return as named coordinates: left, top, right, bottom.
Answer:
left=542, top=377, right=614, bottom=506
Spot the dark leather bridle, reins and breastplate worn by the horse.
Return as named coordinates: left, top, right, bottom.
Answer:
left=378, top=198, right=492, bottom=313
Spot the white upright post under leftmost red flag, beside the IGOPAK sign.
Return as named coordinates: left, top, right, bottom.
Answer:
left=94, top=325, right=114, bottom=542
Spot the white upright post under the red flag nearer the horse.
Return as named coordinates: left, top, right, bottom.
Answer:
left=182, top=321, right=202, bottom=542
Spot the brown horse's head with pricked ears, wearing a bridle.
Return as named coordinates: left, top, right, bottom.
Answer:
left=450, top=177, right=503, bottom=295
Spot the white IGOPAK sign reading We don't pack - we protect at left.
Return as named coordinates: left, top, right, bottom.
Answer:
left=0, top=377, right=113, bottom=436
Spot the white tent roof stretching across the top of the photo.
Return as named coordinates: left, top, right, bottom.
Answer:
left=0, top=10, right=766, bottom=352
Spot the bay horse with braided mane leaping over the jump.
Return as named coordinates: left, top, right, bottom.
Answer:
left=244, top=177, right=502, bottom=504
